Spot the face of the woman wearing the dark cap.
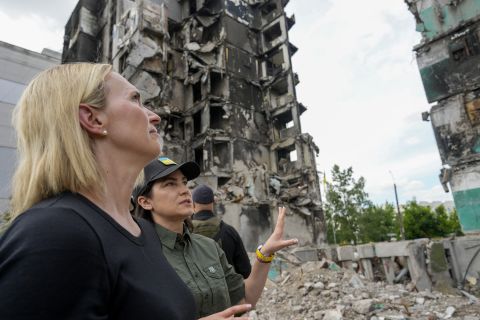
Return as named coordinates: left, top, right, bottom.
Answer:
left=150, top=170, right=193, bottom=224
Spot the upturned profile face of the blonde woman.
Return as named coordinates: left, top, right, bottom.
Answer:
left=101, top=72, right=160, bottom=160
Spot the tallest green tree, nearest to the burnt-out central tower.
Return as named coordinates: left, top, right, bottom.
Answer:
left=325, top=165, right=371, bottom=244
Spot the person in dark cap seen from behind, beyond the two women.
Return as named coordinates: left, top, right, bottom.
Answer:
left=192, top=184, right=252, bottom=279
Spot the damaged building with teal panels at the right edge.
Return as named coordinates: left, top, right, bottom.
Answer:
left=405, top=0, right=480, bottom=233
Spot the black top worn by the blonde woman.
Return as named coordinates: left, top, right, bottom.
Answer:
left=0, top=192, right=195, bottom=320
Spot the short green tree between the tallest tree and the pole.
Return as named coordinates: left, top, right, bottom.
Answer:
left=358, top=203, right=399, bottom=243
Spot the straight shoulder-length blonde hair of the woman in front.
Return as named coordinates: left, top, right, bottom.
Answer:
left=11, top=63, right=112, bottom=220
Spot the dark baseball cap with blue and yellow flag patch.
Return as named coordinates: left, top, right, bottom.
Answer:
left=133, top=157, right=200, bottom=199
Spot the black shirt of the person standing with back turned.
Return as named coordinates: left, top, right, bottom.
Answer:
left=193, top=210, right=252, bottom=279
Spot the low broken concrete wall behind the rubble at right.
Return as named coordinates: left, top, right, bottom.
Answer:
left=326, top=236, right=480, bottom=293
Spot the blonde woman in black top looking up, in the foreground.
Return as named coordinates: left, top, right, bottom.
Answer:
left=0, top=63, right=253, bottom=320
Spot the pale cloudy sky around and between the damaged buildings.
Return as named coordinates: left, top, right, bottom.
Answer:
left=0, top=0, right=452, bottom=203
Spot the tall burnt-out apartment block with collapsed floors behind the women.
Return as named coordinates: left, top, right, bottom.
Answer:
left=62, top=0, right=324, bottom=250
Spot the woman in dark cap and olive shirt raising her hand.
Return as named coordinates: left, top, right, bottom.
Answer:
left=135, top=157, right=297, bottom=317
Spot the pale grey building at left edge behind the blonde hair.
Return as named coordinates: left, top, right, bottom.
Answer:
left=0, top=41, right=61, bottom=214
